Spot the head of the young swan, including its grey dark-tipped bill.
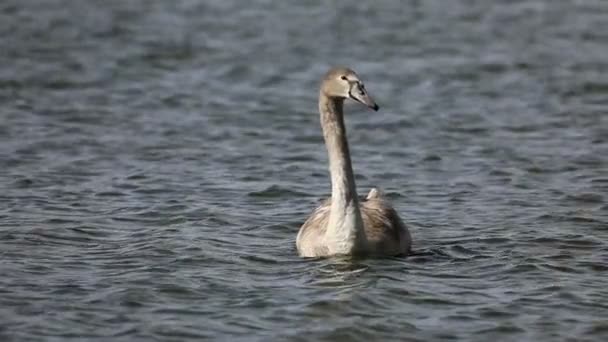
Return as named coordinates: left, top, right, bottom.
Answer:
left=321, top=68, right=380, bottom=111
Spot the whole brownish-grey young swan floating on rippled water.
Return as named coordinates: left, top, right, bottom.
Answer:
left=296, top=68, right=412, bottom=257
